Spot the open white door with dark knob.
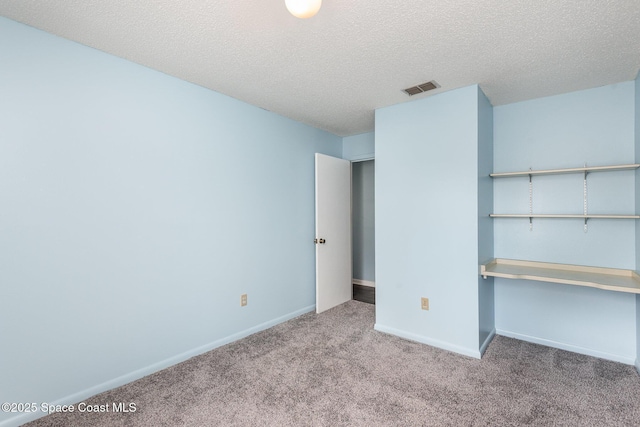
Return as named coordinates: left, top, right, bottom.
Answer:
left=315, top=153, right=353, bottom=313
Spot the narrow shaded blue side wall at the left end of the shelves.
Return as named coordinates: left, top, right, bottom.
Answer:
left=478, top=88, right=495, bottom=348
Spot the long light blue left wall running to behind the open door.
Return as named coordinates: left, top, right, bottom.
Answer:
left=0, top=18, right=342, bottom=425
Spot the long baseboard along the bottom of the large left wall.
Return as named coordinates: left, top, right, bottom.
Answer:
left=0, top=304, right=316, bottom=427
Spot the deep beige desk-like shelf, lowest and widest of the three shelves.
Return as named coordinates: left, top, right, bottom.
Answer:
left=480, top=258, right=640, bottom=294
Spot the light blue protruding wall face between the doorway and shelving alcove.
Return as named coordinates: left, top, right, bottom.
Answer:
left=375, top=86, right=486, bottom=357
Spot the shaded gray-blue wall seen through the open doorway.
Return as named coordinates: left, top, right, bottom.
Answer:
left=351, top=160, right=376, bottom=282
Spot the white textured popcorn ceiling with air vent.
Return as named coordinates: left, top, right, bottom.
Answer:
left=0, top=0, right=640, bottom=136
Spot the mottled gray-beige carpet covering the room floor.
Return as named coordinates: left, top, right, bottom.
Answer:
left=29, top=301, right=640, bottom=427
